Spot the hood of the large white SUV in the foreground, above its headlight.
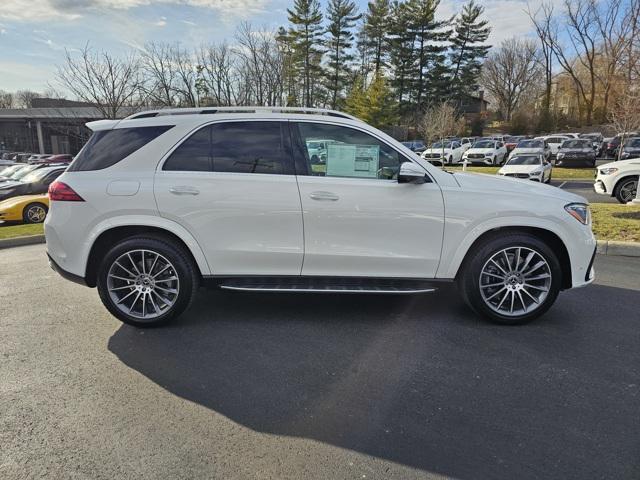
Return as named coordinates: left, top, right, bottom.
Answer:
left=454, top=172, right=589, bottom=203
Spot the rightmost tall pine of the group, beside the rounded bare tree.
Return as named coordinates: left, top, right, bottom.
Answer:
left=451, top=0, right=491, bottom=104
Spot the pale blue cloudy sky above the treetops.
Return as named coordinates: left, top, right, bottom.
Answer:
left=0, top=0, right=548, bottom=91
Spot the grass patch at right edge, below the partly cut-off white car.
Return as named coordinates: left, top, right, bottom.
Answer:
left=591, top=203, right=640, bottom=242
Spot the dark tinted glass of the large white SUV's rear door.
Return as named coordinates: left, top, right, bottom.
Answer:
left=163, top=122, right=292, bottom=174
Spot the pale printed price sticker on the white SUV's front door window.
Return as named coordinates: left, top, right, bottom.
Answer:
left=326, top=144, right=380, bottom=178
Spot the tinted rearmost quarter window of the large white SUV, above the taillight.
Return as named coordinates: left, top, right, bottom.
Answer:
left=69, top=125, right=173, bottom=172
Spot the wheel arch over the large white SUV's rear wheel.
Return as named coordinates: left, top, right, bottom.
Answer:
left=85, top=224, right=210, bottom=287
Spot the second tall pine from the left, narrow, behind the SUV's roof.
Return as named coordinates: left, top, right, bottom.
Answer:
left=325, top=0, right=360, bottom=109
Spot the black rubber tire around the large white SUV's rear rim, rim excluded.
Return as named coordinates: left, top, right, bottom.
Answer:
left=97, top=237, right=198, bottom=328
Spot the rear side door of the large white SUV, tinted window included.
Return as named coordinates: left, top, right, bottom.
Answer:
left=154, top=121, right=304, bottom=275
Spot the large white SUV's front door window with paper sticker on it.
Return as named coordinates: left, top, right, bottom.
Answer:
left=297, top=122, right=408, bottom=180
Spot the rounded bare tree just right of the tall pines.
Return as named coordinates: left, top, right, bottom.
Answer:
left=481, top=38, right=543, bottom=121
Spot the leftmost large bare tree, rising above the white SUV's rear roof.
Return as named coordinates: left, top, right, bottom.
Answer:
left=56, top=45, right=141, bottom=118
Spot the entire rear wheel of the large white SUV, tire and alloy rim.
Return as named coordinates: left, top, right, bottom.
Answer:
left=97, top=236, right=200, bottom=328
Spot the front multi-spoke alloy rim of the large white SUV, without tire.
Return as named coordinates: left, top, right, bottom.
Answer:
left=479, top=246, right=552, bottom=317
